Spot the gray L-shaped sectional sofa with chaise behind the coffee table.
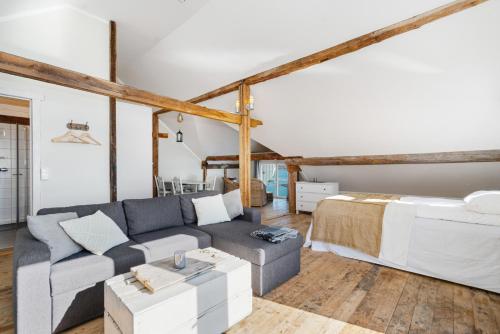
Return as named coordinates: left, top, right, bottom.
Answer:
left=13, top=193, right=303, bottom=334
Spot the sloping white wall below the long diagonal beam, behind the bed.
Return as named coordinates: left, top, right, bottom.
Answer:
left=179, top=2, right=500, bottom=197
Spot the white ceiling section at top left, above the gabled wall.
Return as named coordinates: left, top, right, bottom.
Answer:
left=0, top=0, right=208, bottom=70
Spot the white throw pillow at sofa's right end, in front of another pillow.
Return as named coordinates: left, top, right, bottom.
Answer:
left=192, top=195, right=231, bottom=226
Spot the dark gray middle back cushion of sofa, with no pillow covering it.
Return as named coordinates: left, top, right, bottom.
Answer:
left=123, top=196, right=184, bottom=235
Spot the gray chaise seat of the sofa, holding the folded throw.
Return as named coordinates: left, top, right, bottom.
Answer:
left=190, top=219, right=304, bottom=266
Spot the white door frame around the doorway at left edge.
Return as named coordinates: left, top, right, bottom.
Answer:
left=0, top=86, right=45, bottom=215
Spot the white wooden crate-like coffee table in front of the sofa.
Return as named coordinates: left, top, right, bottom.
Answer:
left=104, top=248, right=252, bottom=334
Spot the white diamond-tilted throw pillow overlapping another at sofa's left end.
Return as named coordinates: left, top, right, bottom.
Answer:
left=59, top=211, right=129, bottom=255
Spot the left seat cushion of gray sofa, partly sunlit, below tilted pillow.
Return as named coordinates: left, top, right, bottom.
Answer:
left=50, top=240, right=148, bottom=296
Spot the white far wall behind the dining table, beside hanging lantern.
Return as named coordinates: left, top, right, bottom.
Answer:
left=158, top=121, right=203, bottom=180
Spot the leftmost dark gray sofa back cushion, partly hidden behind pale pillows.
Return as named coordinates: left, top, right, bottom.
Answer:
left=38, top=202, right=127, bottom=234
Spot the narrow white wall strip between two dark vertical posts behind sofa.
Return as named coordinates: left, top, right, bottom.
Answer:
left=116, top=102, right=153, bottom=200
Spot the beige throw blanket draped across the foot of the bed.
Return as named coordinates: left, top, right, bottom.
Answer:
left=311, top=193, right=400, bottom=257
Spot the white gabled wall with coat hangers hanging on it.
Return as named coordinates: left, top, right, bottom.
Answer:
left=0, top=8, right=109, bottom=207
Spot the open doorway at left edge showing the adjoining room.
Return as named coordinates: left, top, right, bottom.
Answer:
left=0, top=95, right=32, bottom=249
